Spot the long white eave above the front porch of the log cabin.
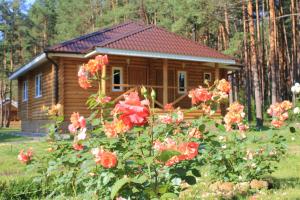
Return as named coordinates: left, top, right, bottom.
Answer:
left=85, top=47, right=236, bottom=66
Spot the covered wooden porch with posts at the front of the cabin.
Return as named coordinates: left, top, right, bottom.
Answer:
left=102, top=56, right=227, bottom=109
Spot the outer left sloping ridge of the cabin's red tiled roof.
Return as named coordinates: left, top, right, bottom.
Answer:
left=45, top=21, right=135, bottom=51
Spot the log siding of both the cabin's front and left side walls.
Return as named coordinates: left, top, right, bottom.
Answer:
left=18, top=55, right=227, bottom=125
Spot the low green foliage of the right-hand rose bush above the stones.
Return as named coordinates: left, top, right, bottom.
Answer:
left=203, top=122, right=286, bottom=182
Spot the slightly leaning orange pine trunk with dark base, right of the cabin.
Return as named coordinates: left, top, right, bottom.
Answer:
left=248, top=0, right=263, bottom=128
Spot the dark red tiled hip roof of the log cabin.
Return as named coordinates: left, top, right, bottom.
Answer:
left=46, top=22, right=233, bottom=60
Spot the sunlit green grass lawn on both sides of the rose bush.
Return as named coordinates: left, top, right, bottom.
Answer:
left=0, top=124, right=300, bottom=199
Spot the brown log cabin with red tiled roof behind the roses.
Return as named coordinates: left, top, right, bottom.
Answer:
left=10, top=22, right=238, bottom=132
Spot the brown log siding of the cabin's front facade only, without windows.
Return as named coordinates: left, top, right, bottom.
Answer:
left=59, top=55, right=226, bottom=119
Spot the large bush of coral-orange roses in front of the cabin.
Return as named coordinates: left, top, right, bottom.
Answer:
left=20, top=56, right=290, bottom=199
